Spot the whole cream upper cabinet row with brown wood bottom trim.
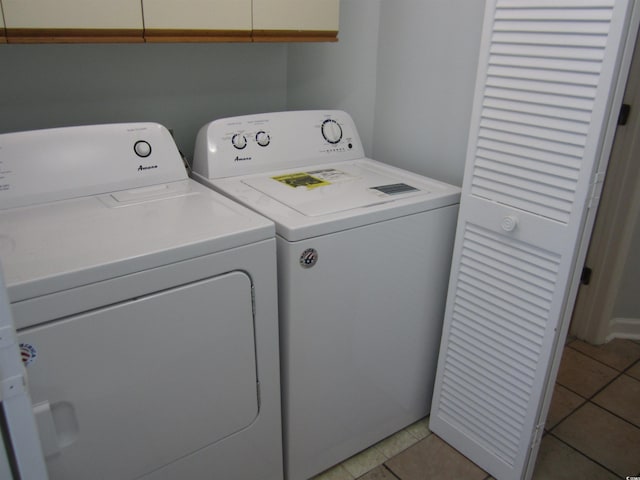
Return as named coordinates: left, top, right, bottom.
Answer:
left=0, top=0, right=340, bottom=43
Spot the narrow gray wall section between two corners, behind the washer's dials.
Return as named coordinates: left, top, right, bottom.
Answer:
left=287, top=0, right=381, bottom=155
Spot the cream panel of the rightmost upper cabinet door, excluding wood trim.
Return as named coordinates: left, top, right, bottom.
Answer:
left=253, top=0, right=340, bottom=31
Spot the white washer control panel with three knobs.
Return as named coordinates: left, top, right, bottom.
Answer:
left=193, top=110, right=364, bottom=179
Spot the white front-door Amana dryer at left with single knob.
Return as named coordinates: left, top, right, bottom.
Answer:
left=0, top=123, right=283, bottom=480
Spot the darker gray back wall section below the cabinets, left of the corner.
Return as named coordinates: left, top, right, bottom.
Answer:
left=0, top=44, right=287, bottom=158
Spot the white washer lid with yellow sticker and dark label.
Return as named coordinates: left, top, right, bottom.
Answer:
left=242, top=162, right=434, bottom=217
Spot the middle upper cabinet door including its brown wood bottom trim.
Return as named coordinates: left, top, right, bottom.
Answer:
left=142, top=0, right=251, bottom=42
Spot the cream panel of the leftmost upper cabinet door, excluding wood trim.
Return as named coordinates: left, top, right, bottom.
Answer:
left=2, top=0, right=142, bottom=29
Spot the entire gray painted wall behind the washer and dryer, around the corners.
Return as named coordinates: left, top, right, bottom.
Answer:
left=0, top=0, right=484, bottom=184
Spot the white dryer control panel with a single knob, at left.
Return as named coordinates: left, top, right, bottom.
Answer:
left=0, top=123, right=187, bottom=210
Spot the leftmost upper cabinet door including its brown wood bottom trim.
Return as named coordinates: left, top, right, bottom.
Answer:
left=2, top=0, right=142, bottom=43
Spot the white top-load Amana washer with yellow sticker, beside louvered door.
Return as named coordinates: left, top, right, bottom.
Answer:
left=193, top=111, right=460, bottom=480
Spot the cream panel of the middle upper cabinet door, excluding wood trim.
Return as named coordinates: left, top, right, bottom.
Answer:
left=142, top=0, right=251, bottom=30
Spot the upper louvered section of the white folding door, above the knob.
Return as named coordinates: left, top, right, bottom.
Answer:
left=471, top=1, right=612, bottom=223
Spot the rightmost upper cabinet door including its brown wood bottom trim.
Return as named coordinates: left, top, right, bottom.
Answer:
left=253, top=0, right=340, bottom=42
